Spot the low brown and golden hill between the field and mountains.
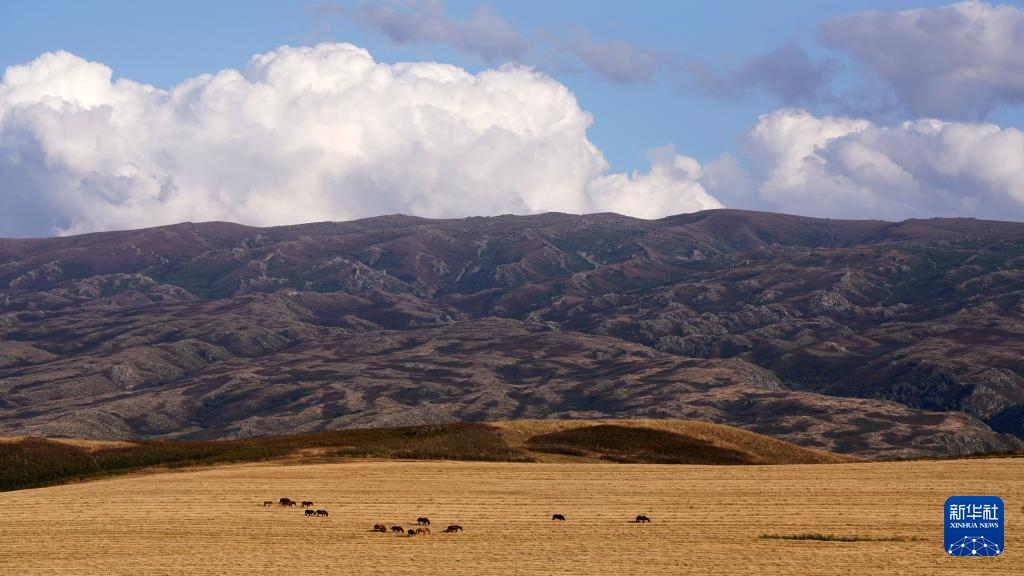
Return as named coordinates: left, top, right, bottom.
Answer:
left=0, top=420, right=851, bottom=491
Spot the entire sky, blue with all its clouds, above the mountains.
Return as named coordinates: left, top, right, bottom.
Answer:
left=0, top=0, right=1024, bottom=237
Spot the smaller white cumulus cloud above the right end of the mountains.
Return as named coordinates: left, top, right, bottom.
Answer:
left=701, top=109, right=1024, bottom=219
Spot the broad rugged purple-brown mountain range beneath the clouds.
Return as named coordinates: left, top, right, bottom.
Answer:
left=0, top=210, right=1024, bottom=457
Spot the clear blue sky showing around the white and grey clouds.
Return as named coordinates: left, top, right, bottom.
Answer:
left=0, top=0, right=1024, bottom=235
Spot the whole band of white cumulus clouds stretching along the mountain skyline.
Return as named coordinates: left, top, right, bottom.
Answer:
left=8, top=34, right=1024, bottom=237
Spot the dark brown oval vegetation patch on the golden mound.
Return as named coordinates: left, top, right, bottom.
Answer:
left=526, top=424, right=756, bottom=464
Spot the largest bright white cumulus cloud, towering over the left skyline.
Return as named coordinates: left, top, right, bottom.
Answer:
left=0, top=44, right=721, bottom=236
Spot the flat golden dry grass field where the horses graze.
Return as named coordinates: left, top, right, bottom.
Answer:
left=0, top=458, right=1024, bottom=576
